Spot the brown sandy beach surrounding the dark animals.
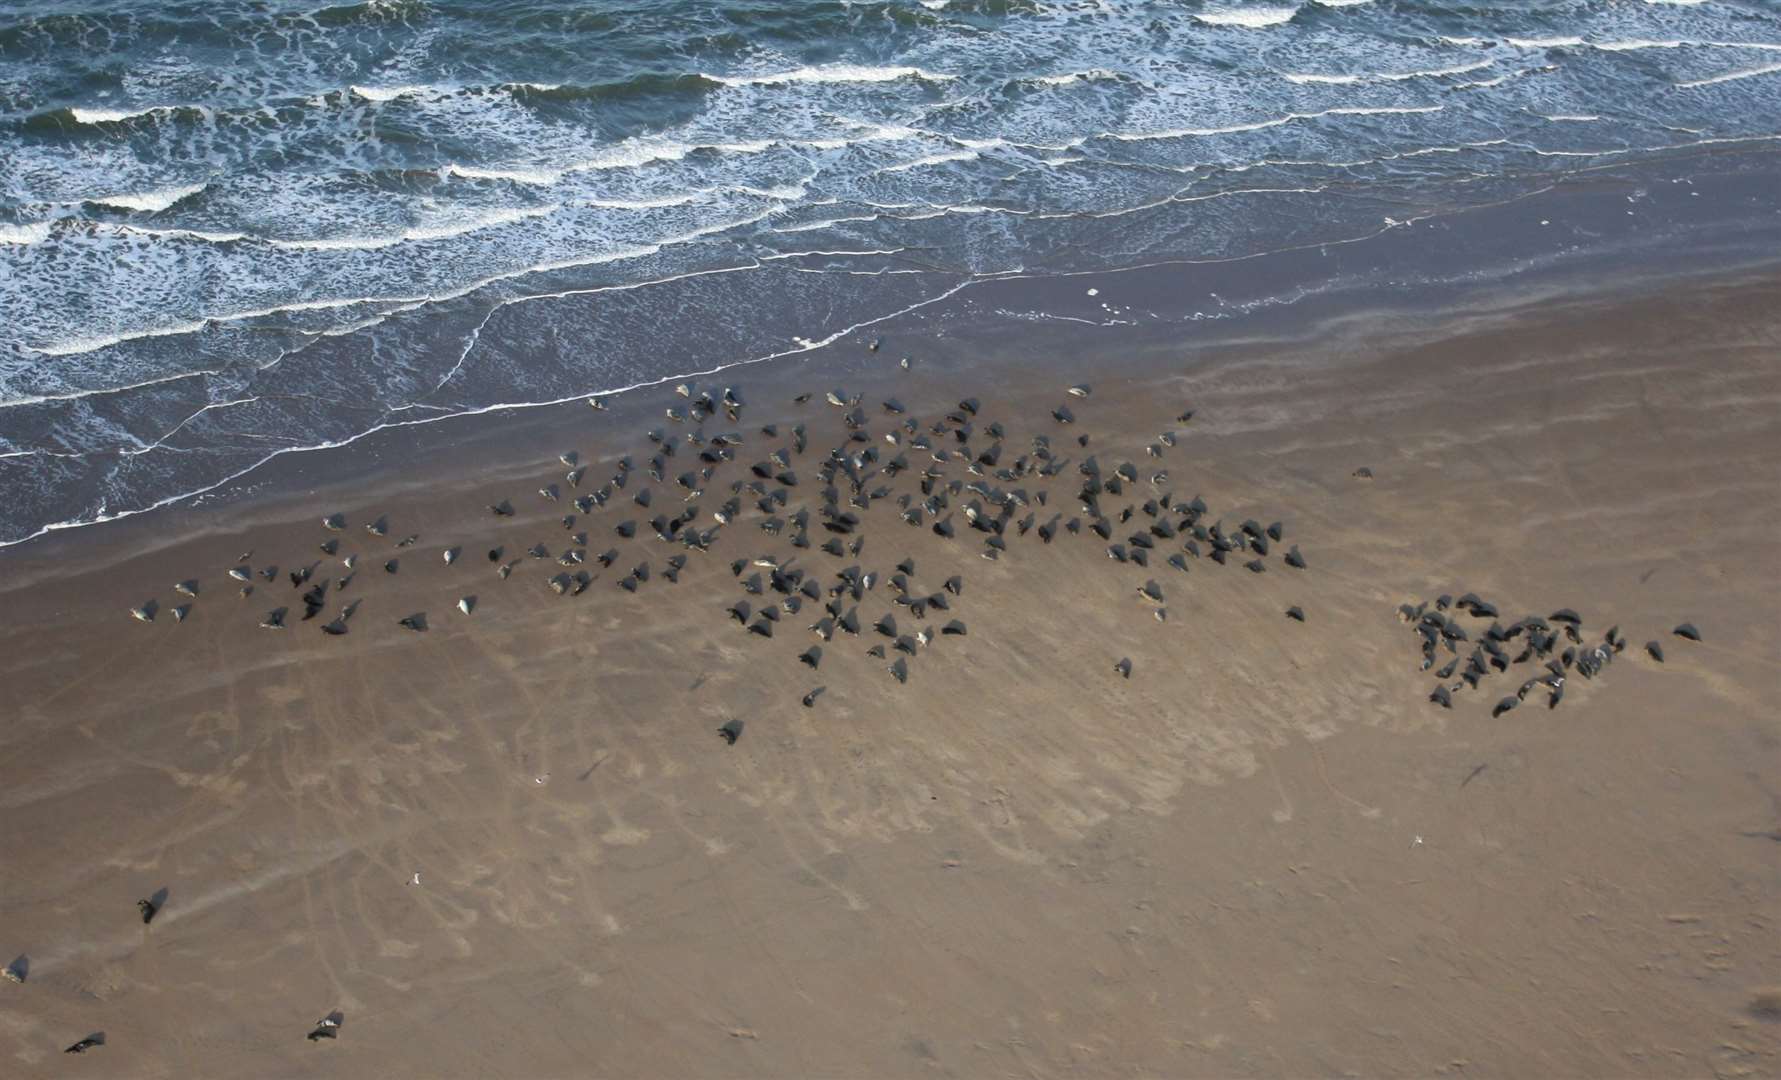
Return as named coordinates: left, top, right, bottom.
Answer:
left=0, top=272, right=1781, bottom=1076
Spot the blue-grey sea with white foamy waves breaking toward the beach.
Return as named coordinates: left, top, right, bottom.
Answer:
left=0, top=0, right=1781, bottom=545
